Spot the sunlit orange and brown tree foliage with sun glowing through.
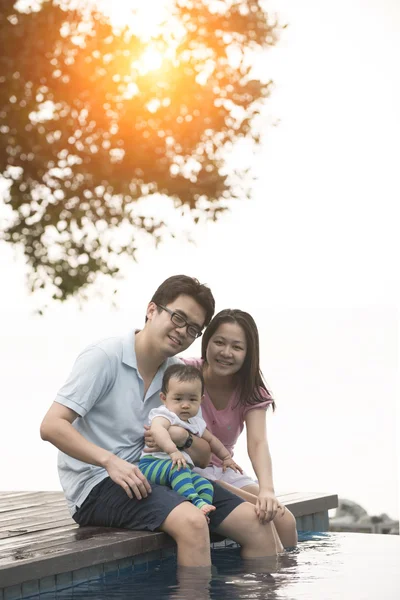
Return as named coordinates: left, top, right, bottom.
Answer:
left=0, top=0, right=277, bottom=300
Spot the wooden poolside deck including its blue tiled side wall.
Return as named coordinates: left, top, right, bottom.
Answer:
left=0, top=492, right=338, bottom=600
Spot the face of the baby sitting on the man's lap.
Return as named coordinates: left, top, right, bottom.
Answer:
left=162, top=377, right=202, bottom=421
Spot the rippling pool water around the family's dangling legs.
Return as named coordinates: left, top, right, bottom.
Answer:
left=44, top=533, right=400, bottom=600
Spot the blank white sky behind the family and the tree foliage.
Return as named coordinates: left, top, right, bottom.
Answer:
left=0, top=0, right=400, bottom=518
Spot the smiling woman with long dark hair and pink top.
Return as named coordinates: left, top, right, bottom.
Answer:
left=184, top=309, right=297, bottom=547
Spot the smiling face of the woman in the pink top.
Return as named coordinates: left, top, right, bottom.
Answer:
left=206, top=323, right=247, bottom=377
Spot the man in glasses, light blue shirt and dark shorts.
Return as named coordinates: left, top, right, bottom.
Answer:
left=40, top=275, right=282, bottom=567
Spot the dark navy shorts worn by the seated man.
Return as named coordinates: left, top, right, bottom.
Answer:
left=73, top=477, right=243, bottom=531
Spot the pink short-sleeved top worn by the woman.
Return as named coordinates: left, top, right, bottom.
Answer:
left=182, top=358, right=272, bottom=467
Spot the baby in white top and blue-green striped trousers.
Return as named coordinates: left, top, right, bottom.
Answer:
left=139, top=364, right=243, bottom=516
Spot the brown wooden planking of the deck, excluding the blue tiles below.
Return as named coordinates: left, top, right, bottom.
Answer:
left=0, top=492, right=337, bottom=600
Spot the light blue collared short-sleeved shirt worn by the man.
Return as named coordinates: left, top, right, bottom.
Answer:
left=55, top=331, right=181, bottom=515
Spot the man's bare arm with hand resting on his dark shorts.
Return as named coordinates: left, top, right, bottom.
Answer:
left=40, top=402, right=151, bottom=500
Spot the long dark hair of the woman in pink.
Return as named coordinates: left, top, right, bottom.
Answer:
left=201, top=308, right=275, bottom=410
